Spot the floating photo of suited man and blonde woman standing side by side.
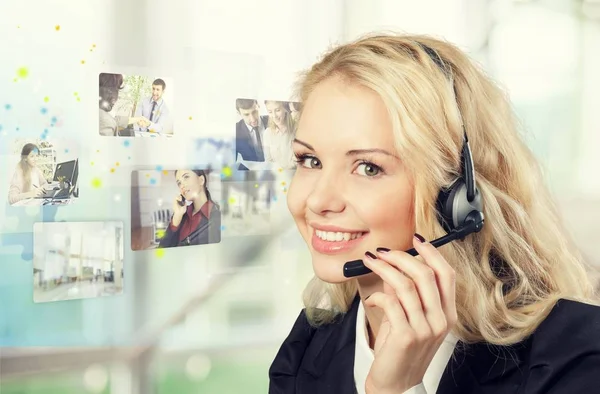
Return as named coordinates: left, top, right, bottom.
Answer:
left=235, top=98, right=301, bottom=171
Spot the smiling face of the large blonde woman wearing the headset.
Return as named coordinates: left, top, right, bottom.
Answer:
left=287, top=79, right=414, bottom=283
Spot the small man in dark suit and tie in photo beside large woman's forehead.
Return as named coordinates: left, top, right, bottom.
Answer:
left=235, top=98, right=268, bottom=170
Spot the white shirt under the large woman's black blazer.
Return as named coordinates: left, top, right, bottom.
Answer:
left=354, top=301, right=458, bottom=394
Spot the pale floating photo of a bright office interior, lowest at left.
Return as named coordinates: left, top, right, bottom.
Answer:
left=33, top=222, right=123, bottom=303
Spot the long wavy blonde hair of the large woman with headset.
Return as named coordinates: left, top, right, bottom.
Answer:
left=296, top=33, right=597, bottom=345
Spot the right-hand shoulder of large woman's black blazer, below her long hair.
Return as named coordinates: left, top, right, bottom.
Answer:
left=440, top=298, right=600, bottom=394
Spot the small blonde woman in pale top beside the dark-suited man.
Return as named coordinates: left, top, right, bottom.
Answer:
left=263, top=100, right=296, bottom=169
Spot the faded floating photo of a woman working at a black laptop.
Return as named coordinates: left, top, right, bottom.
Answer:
left=8, top=140, right=79, bottom=206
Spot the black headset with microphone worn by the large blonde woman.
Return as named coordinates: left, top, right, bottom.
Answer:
left=344, top=43, right=484, bottom=278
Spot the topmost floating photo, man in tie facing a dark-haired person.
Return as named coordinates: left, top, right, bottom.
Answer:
left=98, top=73, right=173, bottom=137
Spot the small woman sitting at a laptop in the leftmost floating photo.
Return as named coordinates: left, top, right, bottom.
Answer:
left=8, top=143, right=48, bottom=205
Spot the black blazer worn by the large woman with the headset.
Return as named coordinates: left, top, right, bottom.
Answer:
left=269, top=296, right=600, bottom=394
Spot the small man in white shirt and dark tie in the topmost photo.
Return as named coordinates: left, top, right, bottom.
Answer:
left=134, top=78, right=173, bottom=134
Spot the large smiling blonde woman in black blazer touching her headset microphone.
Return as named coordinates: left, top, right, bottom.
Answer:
left=269, top=35, right=600, bottom=394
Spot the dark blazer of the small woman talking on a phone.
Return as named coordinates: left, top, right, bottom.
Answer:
left=158, top=204, right=221, bottom=248
